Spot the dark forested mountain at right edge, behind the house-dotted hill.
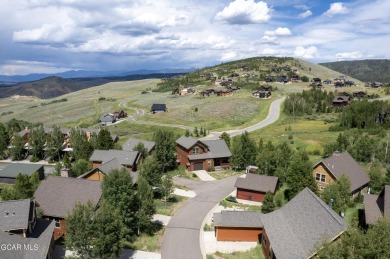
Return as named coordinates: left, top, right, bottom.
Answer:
left=320, top=59, right=390, bottom=83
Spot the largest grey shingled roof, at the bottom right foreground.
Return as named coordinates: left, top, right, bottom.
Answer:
left=262, top=188, right=347, bottom=259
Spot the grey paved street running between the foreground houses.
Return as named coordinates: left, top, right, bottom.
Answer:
left=161, top=176, right=237, bottom=259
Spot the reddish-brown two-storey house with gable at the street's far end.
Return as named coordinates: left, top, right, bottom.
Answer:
left=176, top=136, right=232, bottom=171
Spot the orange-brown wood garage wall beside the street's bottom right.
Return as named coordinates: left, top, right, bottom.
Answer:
left=216, top=227, right=263, bottom=242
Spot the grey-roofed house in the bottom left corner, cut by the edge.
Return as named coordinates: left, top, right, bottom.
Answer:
left=0, top=199, right=54, bottom=259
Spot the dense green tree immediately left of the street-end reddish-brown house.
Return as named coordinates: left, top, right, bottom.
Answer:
left=154, top=130, right=177, bottom=172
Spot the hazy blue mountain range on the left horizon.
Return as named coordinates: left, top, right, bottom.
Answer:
left=0, top=68, right=194, bottom=84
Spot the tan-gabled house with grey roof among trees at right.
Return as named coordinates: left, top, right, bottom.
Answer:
left=312, top=151, right=370, bottom=196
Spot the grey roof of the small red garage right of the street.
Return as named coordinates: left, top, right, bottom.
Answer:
left=234, top=173, right=279, bottom=193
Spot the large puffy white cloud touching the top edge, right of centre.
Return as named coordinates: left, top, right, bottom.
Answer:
left=215, top=0, right=271, bottom=24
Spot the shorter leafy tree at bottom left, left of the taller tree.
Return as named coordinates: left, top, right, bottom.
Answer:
left=65, top=201, right=96, bottom=259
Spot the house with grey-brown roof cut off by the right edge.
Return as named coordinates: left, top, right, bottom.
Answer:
left=364, top=185, right=390, bottom=225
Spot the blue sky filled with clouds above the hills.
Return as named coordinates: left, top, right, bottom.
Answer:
left=0, top=0, right=390, bottom=75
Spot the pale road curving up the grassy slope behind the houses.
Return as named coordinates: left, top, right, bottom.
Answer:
left=201, top=97, right=286, bottom=140
